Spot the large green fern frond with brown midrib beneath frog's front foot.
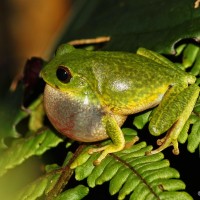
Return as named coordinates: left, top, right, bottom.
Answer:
left=75, top=142, right=192, bottom=200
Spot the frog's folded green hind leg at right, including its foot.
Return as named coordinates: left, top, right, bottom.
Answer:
left=149, top=84, right=199, bottom=155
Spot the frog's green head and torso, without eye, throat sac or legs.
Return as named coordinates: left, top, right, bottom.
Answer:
left=42, top=45, right=195, bottom=115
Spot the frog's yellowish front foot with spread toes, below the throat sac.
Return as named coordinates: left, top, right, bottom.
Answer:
left=88, top=144, right=124, bottom=165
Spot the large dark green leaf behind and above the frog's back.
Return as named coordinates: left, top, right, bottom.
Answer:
left=61, top=0, right=200, bottom=53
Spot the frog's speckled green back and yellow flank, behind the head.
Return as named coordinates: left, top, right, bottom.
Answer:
left=85, top=50, right=192, bottom=114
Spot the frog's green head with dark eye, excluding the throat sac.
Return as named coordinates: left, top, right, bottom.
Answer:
left=40, top=44, right=95, bottom=94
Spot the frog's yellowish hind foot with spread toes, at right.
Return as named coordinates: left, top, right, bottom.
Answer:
left=146, top=131, right=179, bottom=155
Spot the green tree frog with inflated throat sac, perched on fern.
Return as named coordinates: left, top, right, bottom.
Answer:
left=41, top=44, right=200, bottom=164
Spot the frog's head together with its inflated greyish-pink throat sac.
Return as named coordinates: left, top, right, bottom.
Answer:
left=41, top=45, right=104, bottom=142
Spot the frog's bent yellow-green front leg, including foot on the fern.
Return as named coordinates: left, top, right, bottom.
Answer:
left=89, top=115, right=125, bottom=165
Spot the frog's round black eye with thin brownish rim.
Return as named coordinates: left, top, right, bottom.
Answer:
left=56, top=66, right=72, bottom=83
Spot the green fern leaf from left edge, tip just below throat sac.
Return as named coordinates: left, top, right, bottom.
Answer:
left=0, top=129, right=62, bottom=176
